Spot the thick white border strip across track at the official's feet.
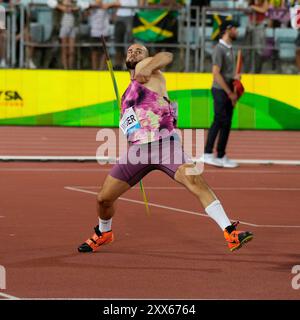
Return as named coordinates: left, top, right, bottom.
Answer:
left=0, top=155, right=300, bottom=166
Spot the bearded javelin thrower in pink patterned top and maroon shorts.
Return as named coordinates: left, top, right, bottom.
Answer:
left=78, top=44, right=253, bottom=252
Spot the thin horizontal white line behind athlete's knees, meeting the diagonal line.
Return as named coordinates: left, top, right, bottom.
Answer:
left=70, top=186, right=300, bottom=191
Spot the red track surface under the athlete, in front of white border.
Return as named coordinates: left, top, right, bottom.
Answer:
left=0, top=162, right=300, bottom=299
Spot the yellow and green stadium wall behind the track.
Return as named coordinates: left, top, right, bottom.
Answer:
left=0, top=69, right=300, bottom=130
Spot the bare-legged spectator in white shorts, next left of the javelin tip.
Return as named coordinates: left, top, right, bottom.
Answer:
left=57, top=0, right=79, bottom=69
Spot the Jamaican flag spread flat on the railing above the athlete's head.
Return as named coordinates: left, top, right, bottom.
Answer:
left=132, top=9, right=177, bottom=42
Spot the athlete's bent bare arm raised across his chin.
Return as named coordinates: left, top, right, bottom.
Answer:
left=135, top=52, right=173, bottom=83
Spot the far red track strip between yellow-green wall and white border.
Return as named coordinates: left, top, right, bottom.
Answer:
left=0, top=127, right=300, bottom=160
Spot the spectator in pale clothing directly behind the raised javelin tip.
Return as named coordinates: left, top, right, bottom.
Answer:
left=89, top=0, right=120, bottom=70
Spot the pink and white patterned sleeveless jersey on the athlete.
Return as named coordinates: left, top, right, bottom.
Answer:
left=121, top=80, right=176, bottom=144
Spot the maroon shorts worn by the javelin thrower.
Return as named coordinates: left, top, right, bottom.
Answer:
left=110, top=134, right=193, bottom=186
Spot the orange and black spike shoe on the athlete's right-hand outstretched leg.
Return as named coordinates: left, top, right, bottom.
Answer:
left=224, top=221, right=253, bottom=251
